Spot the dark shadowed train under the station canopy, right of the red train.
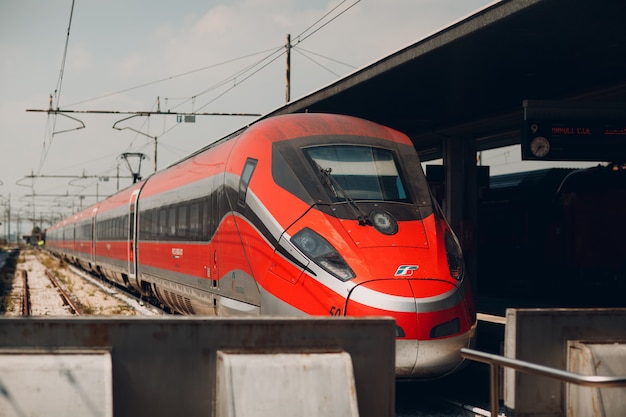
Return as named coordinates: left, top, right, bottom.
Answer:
left=478, top=164, right=626, bottom=307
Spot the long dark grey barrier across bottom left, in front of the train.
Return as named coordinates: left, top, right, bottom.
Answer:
left=0, top=317, right=395, bottom=417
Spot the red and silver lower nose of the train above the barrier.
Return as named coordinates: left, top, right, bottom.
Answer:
left=346, top=279, right=474, bottom=378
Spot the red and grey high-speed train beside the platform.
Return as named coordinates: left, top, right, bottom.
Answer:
left=46, top=114, right=476, bottom=378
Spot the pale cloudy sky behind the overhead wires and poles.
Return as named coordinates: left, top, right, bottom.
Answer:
left=0, top=0, right=596, bottom=236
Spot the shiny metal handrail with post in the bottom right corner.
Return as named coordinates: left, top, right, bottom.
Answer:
left=461, top=348, right=626, bottom=417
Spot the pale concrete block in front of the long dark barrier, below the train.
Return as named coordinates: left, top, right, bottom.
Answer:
left=216, top=351, right=359, bottom=417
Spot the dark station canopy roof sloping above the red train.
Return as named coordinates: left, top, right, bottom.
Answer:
left=267, top=0, right=626, bottom=160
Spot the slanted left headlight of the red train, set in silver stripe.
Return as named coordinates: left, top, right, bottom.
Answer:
left=291, top=227, right=356, bottom=281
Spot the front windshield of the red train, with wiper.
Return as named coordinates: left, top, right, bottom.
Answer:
left=302, top=145, right=409, bottom=202
